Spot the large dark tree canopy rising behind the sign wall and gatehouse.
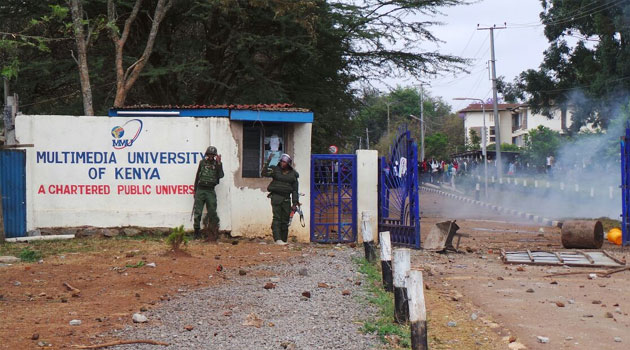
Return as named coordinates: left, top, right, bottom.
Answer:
left=0, top=0, right=465, bottom=151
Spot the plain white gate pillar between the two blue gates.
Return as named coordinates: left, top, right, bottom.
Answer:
left=356, top=150, right=378, bottom=242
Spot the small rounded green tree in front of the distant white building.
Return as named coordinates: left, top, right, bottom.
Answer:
left=523, top=125, right=562, bottom=167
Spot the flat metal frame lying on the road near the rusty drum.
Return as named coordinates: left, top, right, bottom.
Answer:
left=501, top=250, right=625, bottom=267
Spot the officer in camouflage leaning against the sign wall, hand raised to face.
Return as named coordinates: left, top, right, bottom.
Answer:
left=193, top=146, right=223, bottom=240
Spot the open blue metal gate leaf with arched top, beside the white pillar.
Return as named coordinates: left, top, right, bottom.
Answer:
left=378, top=126, right=420, bottom=249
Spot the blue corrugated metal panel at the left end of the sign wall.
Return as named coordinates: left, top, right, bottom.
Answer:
left=0, top=150, right=26, bottom=238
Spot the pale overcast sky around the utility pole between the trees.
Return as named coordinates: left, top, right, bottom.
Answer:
left=386, top=0, right=549, bottom=110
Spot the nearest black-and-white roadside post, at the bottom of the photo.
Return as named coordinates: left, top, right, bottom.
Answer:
left=407, top=270, right=429, bottom=350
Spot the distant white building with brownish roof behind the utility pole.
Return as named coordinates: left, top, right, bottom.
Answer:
left=458, top=103, right=571, bottom=146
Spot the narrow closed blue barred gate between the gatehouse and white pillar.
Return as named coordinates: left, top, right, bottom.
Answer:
left=311, top=154, right=357, bottom=243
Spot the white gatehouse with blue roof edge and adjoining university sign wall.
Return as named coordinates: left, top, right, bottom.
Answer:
left=16, top=105, right=313, bottom=241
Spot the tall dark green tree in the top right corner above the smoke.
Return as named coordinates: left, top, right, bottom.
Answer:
left=515, top=0, right=630, bottom=132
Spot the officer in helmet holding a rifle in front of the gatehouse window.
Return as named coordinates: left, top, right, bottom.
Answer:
left=262, top=154, right=300, bottom=244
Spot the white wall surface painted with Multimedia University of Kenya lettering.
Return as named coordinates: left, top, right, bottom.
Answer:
left=16, top=115, right=311, bottom=240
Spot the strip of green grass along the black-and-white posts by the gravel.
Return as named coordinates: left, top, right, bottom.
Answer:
left=355, top=258, right=411, bottom=349
